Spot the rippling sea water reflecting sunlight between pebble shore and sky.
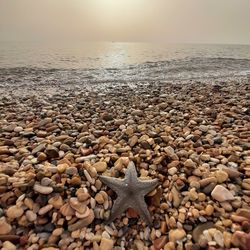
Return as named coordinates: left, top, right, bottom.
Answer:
left=0, top=42, right=250, bottom=84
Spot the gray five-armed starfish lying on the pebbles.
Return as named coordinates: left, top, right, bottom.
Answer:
left=99, top=161, right=159, bottom=225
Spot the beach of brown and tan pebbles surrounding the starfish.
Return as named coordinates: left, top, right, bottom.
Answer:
left=0, top=77, right=250, bottom=250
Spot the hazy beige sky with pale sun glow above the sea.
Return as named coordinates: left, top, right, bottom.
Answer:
left=0, top=0, right=250, bottom=44
